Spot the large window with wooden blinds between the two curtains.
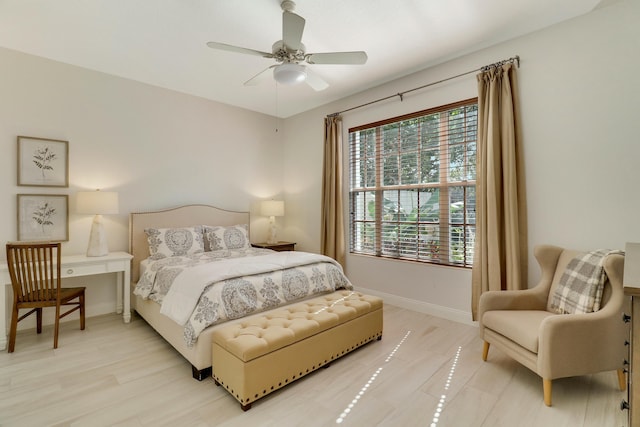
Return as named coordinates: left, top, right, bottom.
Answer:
left=349, top=98, right=478, bottom=267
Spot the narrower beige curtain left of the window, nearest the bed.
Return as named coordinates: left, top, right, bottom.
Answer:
left=320, top=116, right=345, bottom=266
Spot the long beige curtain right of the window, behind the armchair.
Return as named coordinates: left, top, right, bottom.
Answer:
left=471, top=64, right=528, bottom=320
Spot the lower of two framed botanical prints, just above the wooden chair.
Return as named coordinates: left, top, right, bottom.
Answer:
left=18, top=194, right=69, bottom=242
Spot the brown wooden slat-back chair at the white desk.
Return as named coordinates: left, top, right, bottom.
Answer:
left=7, top=242, right=85, bottom=353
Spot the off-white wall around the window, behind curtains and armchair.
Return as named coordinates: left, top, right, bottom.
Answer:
left=284, top=0, right=640, bottom=321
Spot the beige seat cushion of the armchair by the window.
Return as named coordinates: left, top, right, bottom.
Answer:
left=482, top=310, right=559, bottom=354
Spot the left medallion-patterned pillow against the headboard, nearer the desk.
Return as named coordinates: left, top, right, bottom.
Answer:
left=144, top=225, right=204, bottom=259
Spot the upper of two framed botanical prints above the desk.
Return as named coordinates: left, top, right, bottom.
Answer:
left=18, top=136, right=69, bottom=187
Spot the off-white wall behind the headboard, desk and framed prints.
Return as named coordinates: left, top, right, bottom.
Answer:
left=0, top=49, right=283, bottom=328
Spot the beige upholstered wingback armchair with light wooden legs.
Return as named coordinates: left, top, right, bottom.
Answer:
left=478, top=245, right=628, bottom=406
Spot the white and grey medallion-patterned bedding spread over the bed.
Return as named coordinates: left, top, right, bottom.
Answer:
left=134, top=248, right=353, bottom=345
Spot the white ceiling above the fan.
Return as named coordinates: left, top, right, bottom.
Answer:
left=0, top=0, right=615, bottom=118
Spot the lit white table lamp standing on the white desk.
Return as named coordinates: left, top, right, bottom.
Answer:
left=76, top=190, right=118, bottom=256
